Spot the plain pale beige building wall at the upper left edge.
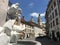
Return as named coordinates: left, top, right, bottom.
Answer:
left=0, top=0, right=9, bottom=26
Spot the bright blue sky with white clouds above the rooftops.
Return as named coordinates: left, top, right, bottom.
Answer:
left=10, top=0, right=49, bottom=23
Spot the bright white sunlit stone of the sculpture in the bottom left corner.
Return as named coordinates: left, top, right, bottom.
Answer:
left=0, top=27, right=10, bottom=45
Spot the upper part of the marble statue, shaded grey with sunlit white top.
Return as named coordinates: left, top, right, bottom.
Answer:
left=7, top=3, right=22, bottom=19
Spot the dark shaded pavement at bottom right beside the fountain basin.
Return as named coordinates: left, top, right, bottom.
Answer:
left=36, top=37, right=60, bottom=45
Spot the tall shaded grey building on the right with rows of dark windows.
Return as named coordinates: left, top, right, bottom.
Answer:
left=45, top=0, right=60, bottom=40
